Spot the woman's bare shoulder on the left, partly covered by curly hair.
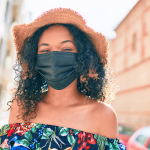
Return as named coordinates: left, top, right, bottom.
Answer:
left=8, top=100, right=23, bottom=124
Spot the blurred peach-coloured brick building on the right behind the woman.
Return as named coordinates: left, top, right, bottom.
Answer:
left=109, top=0, right=150, bottom=128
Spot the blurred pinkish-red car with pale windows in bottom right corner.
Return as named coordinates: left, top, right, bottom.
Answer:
left=127, top=126, right=150, bottom=150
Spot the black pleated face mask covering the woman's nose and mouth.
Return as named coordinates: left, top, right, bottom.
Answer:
left=35, top=51, right=78, bottom=90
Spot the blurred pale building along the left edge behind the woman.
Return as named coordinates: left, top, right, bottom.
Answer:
left=0, top=0, right=31, bottom=127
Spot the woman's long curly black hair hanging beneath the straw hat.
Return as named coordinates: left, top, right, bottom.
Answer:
left=9, top=24, right=106, bottom=121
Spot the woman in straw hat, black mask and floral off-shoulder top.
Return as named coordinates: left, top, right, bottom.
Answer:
left=0, top=8, right=125, bottom=150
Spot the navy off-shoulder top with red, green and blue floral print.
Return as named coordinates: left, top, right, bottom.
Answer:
left=0, top=123, right=126, bottom=150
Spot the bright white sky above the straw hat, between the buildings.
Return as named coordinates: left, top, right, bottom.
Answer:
left=25, top=0, right=138, bottom=39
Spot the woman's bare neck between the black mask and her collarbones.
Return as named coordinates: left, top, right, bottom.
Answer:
left=43, top=79, right=86, bottom=107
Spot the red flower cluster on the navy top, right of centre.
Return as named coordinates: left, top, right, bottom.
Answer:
left=77, top=132, right=96, bottom=150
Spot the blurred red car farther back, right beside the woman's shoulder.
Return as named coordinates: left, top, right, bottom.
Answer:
left=118, top=123, right=135, bottom=146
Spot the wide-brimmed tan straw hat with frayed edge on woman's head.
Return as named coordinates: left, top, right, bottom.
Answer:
left=13, top=8, right=108, bottom=66
